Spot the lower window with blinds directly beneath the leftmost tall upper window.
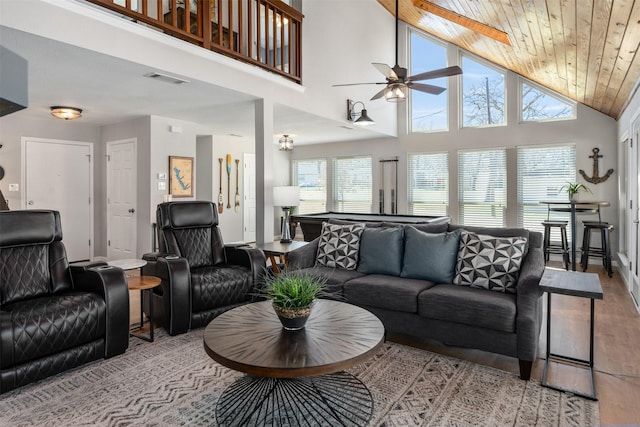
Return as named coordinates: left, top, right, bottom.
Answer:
left=409, top=153, right=449, bottom=216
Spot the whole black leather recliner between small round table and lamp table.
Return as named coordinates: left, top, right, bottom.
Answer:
left=142, top=201, right=266, bottom=335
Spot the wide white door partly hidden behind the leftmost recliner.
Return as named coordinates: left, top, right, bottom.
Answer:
left=22, top=138, right=93, bottom=262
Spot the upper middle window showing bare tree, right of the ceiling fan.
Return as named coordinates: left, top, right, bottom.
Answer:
left=462, top=56, right=506, bottom=127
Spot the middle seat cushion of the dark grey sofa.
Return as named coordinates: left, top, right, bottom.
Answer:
left=343, top=274, right=435, bottom=313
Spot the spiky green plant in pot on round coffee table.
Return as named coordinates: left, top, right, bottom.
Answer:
left=259, top=270, right=326, bottom=331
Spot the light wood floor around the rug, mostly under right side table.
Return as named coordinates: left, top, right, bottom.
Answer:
left=130, top=263, right=640, bottom=425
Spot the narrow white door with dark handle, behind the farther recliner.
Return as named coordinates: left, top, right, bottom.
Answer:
left=107, top=139, right=137, bottom=260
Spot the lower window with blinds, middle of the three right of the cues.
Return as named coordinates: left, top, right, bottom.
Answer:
left=458, top=149, right=507, bottom=227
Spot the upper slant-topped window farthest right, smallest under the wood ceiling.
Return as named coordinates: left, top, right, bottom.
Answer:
left=520, top=82, right=576, bottom=122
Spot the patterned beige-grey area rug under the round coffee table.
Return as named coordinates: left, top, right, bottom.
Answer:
left=0, top=329, right=599, bottom=427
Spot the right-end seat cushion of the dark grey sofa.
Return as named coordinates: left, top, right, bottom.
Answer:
left=418, top=285, right=516, bottom=332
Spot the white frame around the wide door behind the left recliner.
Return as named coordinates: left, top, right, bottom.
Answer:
left=20, top=136, right=96, bottom=259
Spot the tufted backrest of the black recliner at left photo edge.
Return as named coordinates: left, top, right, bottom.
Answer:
left=0, top=210, right=73, bottom=306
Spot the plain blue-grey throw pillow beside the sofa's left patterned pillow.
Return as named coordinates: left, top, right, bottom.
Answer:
left=357, top=227, right=404, bottom=276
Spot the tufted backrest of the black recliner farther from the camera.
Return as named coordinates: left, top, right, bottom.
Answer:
left=156, top=201, right=226, bottom=268
